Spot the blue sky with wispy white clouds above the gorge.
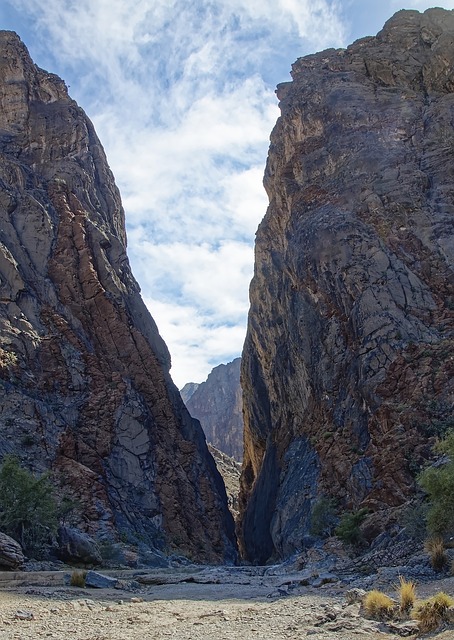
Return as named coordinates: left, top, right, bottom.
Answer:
left=0, top=0, right=454, bottom=388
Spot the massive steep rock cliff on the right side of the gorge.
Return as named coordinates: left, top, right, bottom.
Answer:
left=240, top=9, right=454, bottom=562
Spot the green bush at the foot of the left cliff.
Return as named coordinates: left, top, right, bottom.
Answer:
left=0, top=456, right=58, bottom=555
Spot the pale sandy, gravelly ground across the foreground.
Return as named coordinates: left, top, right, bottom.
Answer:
left=0, top=578, right=454, bottom=640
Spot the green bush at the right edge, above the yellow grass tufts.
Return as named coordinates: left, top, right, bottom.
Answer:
left=418, top=431, right=454, bottom=537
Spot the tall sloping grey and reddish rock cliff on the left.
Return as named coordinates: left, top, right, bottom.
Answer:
left=0, top=31, right=235, bottom=561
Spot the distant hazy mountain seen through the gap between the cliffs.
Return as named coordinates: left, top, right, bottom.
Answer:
left=181, top=358, right=243, bottom=461
